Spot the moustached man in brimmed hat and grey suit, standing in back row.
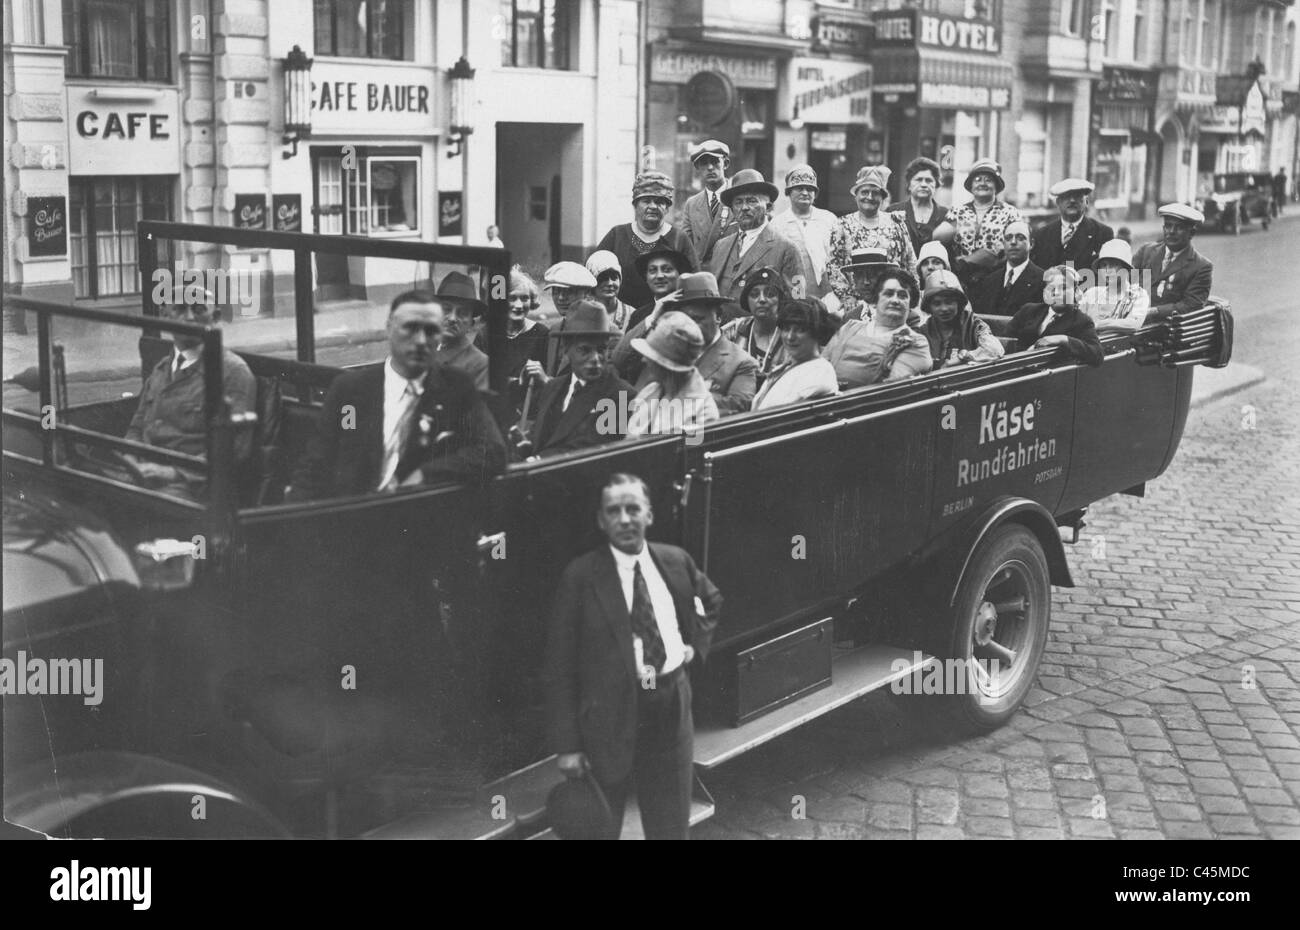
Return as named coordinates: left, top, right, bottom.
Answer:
left=709, top=168, right=813, bottom=300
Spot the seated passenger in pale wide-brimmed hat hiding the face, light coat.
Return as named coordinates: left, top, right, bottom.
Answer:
left=628, top=310, right=718, bottom=437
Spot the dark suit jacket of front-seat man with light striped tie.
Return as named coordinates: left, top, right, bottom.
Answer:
left=293, top=362, right=506, bottom=499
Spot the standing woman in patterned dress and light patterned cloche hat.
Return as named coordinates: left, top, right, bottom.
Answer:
left=826, top=165, right=917, bottom=323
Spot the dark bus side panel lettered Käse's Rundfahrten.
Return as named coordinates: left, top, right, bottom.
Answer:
left=928, top=368, right=1075, bottom=538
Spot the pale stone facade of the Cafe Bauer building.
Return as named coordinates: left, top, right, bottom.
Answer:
left=4, top=0, right=644, bottom=312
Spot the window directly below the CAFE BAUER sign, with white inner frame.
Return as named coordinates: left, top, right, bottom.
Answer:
left=312, top=147, right=420, bottom=237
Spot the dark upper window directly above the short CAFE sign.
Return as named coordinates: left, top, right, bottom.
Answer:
left=64, top=0, right=172, bottom=82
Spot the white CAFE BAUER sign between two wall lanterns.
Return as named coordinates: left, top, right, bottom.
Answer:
left=312, top=60, right=437, bottom=135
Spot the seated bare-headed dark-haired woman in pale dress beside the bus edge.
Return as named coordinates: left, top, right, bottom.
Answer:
left=826, top=271, right=933, bottom=390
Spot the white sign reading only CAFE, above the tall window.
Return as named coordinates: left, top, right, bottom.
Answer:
left=68, top=85, right=181, bottom=174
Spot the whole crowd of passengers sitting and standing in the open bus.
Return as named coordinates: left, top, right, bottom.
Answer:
left=122, top=148, right=1212, bottom=497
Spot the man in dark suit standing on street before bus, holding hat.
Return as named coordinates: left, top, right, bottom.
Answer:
left=545, top=473, right=723, bottom=839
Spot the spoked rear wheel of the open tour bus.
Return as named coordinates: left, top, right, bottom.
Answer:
left=927, top=523, right=1052, bottom=734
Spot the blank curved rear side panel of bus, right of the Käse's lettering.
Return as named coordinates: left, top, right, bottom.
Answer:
left=1056, top=354, right=1186, bottom=512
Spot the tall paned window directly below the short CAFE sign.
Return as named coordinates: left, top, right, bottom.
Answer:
left=68, top=177, right=172, bottom=298
